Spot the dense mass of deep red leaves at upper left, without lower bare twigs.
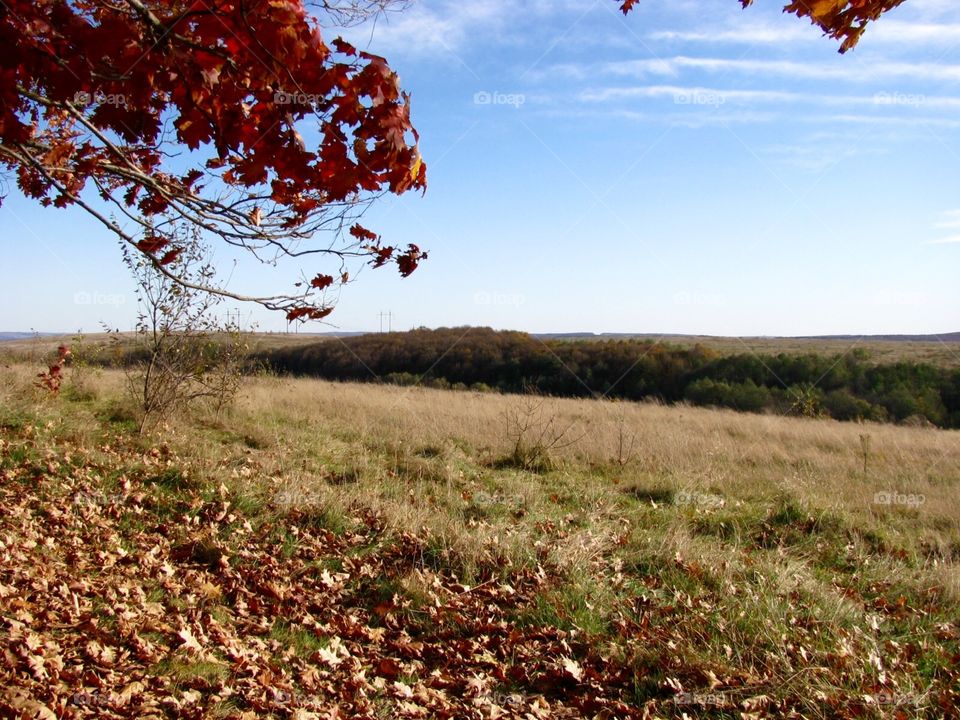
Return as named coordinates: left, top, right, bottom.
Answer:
left=0, top=0, right=426, bottom=248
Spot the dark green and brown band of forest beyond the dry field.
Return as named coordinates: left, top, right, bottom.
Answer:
left=259, top=328, right=960, bottom=428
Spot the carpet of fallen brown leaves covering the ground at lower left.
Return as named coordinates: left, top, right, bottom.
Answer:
left=0, top=428, right=958, bottom=720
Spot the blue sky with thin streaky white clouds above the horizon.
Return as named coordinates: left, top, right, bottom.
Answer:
left=0, top=0, right=960, bottom=335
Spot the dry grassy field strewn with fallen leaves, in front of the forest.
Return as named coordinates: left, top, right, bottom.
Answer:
left=0, top=364, right=960, bottom=718
